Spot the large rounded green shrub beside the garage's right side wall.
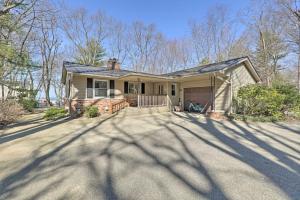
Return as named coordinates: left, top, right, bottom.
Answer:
left=235, top=85, right=285, bottom=119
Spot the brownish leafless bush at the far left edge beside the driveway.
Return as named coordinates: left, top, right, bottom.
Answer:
left=0, top=100, right=22, bottom=127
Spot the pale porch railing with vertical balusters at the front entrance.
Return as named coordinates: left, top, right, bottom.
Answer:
left=137, top=95, right=167, bottom=107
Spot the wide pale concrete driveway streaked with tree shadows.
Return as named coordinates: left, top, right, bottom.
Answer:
left=0, top=113, right=300, bottom=200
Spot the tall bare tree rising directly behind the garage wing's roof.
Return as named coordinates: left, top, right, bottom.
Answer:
left=190, top=5, right=236, bottom=63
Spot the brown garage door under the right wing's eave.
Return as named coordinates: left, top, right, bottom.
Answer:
left=184, top=87, right=211, bottom=110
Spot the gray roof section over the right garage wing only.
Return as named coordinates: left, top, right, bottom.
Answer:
left=164, top=57, right=248, bottom=76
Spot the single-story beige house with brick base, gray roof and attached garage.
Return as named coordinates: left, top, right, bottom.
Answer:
left=62, top=57, right=260, bottom=113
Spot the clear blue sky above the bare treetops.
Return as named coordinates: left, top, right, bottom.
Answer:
left=65, top=0, right=250, bottom=38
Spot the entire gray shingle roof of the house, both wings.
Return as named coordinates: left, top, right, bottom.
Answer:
left=64, top=57, right=258, bottom=78
